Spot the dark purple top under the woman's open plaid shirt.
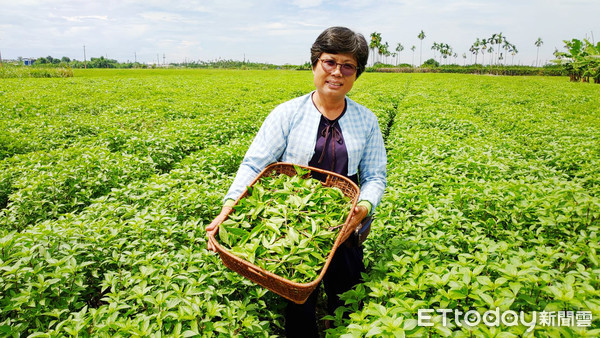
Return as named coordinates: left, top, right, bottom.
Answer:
left=308, top=103, right=358, bottom=185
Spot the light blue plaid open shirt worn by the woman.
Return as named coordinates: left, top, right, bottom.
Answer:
left=224, top=92, right=387, bottom=211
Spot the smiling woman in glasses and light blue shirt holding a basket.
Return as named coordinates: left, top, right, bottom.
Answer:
left=206, top=27, right=387, bottom=337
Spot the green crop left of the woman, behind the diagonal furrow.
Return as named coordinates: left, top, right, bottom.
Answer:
left=0, top=73, right=314, bottom=229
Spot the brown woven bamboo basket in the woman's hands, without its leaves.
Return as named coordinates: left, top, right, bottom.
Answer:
left=208, top=162, right=360, bottom=304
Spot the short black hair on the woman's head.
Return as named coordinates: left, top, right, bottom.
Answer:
left=310, top=27, right=369, bottom=78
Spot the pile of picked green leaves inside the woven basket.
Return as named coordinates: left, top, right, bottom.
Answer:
left=219, top=167, right=351, bottom=283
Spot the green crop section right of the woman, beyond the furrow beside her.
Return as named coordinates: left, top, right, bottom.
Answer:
left=331, top=76, right=600, bottom=336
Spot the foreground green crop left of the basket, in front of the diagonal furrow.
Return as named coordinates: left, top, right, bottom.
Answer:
left=0, top=142, right=290, bottom=336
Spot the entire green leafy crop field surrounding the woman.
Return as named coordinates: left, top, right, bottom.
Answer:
left=0, top=70, right=600, bottom=337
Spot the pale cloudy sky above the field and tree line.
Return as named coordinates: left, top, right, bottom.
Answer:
left=0, top=0, right=600, bottom=65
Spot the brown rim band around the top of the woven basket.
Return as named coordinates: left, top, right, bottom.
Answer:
left=208, top=162, right=360, bottom=296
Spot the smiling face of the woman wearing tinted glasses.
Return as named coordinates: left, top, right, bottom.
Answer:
left=313, top=53, right=357, bottom=99
